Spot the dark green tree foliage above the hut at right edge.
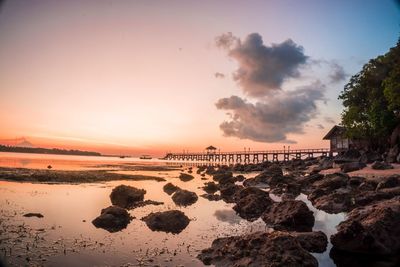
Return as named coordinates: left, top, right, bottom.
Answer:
left=339, top=41, right=400, bottom=148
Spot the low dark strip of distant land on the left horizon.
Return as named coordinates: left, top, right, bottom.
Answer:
left=0, top=145, right=102, bottom=156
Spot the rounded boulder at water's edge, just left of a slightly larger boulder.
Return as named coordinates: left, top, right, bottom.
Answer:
left=233, top=187, right=273, bottom=221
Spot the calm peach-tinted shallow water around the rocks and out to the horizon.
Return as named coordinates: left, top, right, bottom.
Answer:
left=0, top=153, right=344, bottom=267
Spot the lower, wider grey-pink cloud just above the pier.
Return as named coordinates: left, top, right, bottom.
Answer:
left=215, top=81, right=325, bottom=143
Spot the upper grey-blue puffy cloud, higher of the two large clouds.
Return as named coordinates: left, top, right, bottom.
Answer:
left=215, top=33, right=308, bottom=97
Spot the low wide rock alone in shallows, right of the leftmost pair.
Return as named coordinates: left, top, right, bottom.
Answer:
left=142, top=210, right=190, bottom=234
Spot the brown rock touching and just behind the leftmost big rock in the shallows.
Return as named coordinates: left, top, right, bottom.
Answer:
left=110, top=185, right=146, bottom=209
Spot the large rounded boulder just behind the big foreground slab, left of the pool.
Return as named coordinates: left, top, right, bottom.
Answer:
left=261, top=200, right=315, bottom=232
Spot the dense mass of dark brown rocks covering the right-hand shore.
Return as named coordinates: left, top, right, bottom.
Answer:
left=193, top=151, right=400, bottom=266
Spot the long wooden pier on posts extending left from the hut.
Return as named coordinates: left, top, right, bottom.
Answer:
left=163, top=148, right=330, bottom=163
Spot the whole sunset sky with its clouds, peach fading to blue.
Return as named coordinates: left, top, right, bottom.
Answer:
left=0, top=0, right=400, bottom=155
